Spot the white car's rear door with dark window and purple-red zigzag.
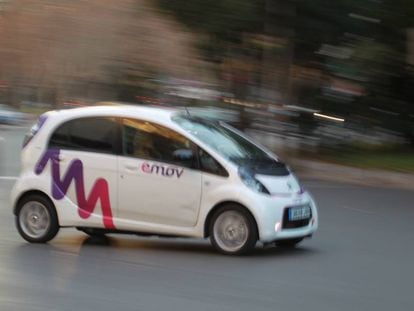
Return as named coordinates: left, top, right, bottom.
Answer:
left=48, top=117, right=120, bottom=229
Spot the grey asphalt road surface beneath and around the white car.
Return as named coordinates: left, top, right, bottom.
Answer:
left=0, top=125, right=414, bottom=311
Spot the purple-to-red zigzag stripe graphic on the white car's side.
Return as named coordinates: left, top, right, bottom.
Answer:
left=35, top=149, right=115, bottom=229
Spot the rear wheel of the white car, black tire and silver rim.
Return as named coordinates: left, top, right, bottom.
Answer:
left=15, top=194, right=59, bottom=243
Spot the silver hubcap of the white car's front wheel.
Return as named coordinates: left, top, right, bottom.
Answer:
left=213, top=211, right=249, bottom=252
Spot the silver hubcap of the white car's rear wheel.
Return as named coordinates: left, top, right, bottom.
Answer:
left=19, top=201, right=50, bottom=239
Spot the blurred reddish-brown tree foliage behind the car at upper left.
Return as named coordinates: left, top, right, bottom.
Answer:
left=0, top=0, right=208, bottom=104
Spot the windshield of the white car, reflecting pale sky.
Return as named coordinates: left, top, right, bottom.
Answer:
left=173, top=117, right=274, bottom=163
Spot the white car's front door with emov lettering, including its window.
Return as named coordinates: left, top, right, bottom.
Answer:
left=119, top=119, right=201, bottom=227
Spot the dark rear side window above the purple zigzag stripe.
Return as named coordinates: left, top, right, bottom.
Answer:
left=49, top=117, right=118, bottom=153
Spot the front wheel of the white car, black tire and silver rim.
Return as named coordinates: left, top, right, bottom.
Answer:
left=209, top=204, right=258, bottom=255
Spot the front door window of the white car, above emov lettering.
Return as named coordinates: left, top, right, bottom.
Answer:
left=122, top=119, right=195, bottom=168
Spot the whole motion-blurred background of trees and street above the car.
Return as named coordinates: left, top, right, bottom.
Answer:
left=0, top=0, right=414, bottom=175
